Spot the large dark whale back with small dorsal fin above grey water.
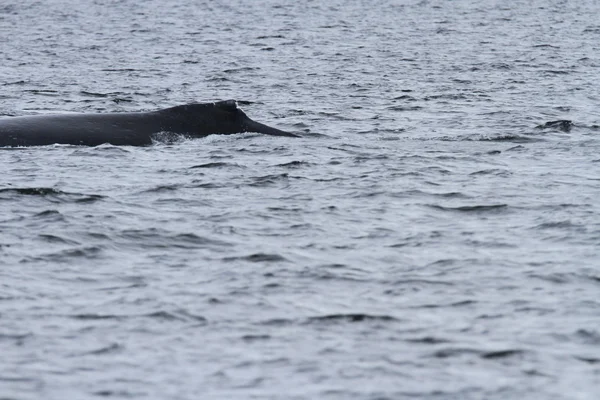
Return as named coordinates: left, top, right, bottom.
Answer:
left=0, top=100, right=298, bottom=147
